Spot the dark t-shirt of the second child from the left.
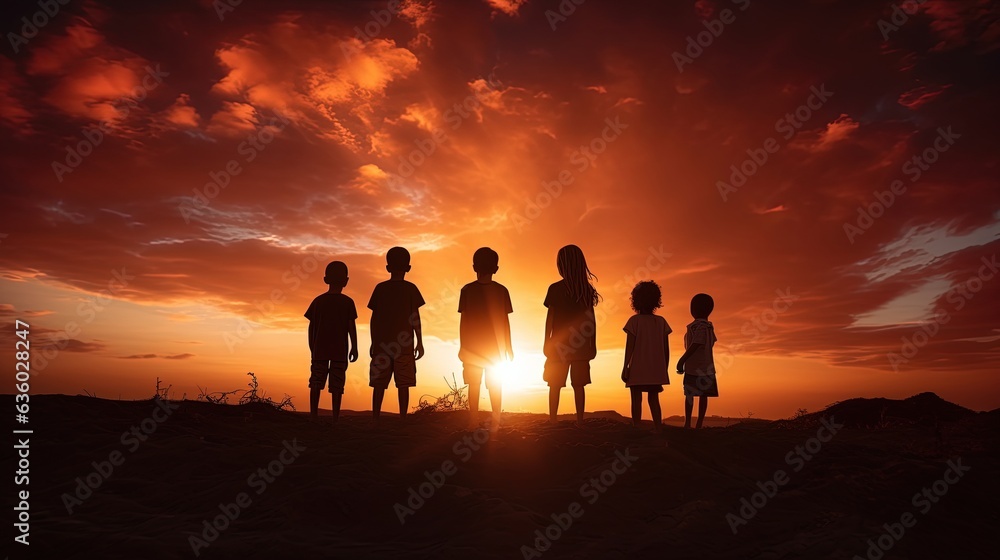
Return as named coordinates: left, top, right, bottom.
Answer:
left=368, top=280, right=424, bottom=356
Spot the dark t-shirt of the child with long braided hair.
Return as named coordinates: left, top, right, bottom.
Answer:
left=545, top=280, right=597, bottom=362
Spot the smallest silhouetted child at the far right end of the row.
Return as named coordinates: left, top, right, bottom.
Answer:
left=677, top=294, right=719, bottom=428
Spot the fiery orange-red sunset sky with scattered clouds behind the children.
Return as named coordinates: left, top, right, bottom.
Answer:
left=0, top=0, right=1000, bottom=418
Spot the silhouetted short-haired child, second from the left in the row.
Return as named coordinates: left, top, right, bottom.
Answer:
left=368, top=247, right=424, bottom=424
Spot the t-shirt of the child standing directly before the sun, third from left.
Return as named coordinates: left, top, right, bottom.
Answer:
left=458, top=281, right=514, bottom=367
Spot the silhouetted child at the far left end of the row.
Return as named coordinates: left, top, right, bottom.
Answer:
left=306, top=261, right=358, bottom=421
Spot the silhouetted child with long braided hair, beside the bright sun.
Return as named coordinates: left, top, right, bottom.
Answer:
left=543, top=245, right=601, bottom=425
